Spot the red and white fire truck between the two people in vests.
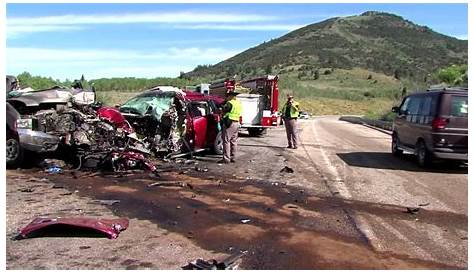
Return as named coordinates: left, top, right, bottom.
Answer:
left=237, top=75, right=281, bottom=136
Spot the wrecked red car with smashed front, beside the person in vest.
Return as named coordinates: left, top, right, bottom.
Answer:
left=119, top=87, right=222, bottom=157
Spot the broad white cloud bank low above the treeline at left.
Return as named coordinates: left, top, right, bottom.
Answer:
left=6, top=47, right=240, bottom=79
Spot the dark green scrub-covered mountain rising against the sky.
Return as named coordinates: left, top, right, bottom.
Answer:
left=185, top=11, right=468, bottom=81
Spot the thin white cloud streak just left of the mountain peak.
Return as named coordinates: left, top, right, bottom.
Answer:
left=173, top=24, right=305, bottom=31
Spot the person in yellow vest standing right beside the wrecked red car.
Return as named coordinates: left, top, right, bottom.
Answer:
left=218, top=92, right=242, bottom=164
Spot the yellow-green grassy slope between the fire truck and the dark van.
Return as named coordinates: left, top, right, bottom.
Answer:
left=279, top=68, right=406, bottom=119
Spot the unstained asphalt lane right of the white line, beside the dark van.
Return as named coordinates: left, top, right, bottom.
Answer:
left=296, top=117, right=468, bottom=268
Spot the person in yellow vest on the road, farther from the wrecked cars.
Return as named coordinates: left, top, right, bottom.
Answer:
left=281, top=95, right=300, bottom=149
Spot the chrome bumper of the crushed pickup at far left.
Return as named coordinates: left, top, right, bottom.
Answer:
left=18, top=128, right=60, bottom=152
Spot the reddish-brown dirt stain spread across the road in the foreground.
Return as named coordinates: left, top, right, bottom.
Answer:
left=20, top=169, right=467, bottom=269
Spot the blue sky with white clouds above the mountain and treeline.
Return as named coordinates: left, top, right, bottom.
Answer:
left=6, top=3, right=468, bottom=79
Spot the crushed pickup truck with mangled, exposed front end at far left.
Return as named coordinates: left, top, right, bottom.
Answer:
left=7, top=87, right=155, bottom=171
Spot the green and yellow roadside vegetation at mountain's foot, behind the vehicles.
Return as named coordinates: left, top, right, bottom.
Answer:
left=12, top=62, right=468, bottom=121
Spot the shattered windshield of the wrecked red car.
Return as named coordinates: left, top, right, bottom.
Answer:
left=120, top=93, right=174, bottom=120
